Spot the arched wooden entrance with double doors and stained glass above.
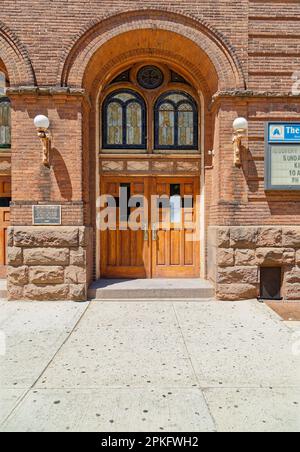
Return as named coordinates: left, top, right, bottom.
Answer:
left=98, top=60, right=201, bottom=278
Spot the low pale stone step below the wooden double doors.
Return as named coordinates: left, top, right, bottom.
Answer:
left=88, top=279, right=215, bottom=301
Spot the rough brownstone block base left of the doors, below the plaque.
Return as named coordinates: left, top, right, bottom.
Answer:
left=7, top=226, right=92, bottom=301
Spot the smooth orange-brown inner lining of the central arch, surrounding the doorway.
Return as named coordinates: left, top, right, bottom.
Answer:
left=74, top=28, right=219, bottom=278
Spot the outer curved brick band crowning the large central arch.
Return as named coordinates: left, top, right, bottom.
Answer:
left=58, top=9, right=246, bottom=94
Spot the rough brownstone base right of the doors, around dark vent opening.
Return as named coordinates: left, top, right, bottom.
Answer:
left=208, top=226, right=300, bottom=300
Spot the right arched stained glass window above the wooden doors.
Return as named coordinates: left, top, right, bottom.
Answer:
left=155, top=92, right=198, bottom=150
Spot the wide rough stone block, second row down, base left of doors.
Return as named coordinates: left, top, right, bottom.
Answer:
left=23, top=248, right=70, bottom=266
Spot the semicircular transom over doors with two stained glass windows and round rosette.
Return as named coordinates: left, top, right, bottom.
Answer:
left=102, top=66, right=199, bottom=153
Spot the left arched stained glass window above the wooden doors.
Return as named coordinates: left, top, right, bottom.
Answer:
left=103, top=90, right=146, bottom=149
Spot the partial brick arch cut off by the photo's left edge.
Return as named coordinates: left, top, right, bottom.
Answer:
left=0, top=21, right=36, bottom=86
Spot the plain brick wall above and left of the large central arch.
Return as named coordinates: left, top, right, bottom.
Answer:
left=1, top=0, right=248, bottom=85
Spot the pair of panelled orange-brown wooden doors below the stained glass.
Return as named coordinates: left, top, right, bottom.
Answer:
left=101, top=177, right=200, bottom=278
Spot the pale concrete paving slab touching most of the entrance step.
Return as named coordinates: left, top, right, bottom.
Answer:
left=37, top=302, right=197, bottom=388
